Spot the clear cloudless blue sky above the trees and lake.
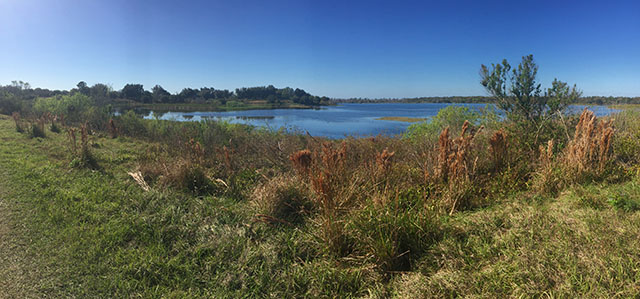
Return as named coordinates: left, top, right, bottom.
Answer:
left=0, top=0, right=640, bottom=98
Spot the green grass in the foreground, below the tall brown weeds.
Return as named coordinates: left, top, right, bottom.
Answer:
left=0, top=116, right=640, bottom=298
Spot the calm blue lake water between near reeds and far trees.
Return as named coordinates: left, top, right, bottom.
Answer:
left=145, top=103, right=616, bottom=138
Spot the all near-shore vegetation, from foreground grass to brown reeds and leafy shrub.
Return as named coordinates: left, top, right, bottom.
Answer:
left=0, top=55, right=640, bottom=298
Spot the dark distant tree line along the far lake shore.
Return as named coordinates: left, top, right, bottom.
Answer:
left=0, top=81, right=640, bottom=114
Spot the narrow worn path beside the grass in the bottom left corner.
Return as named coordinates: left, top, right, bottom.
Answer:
left=0, top=169, right=46, bottom=298
